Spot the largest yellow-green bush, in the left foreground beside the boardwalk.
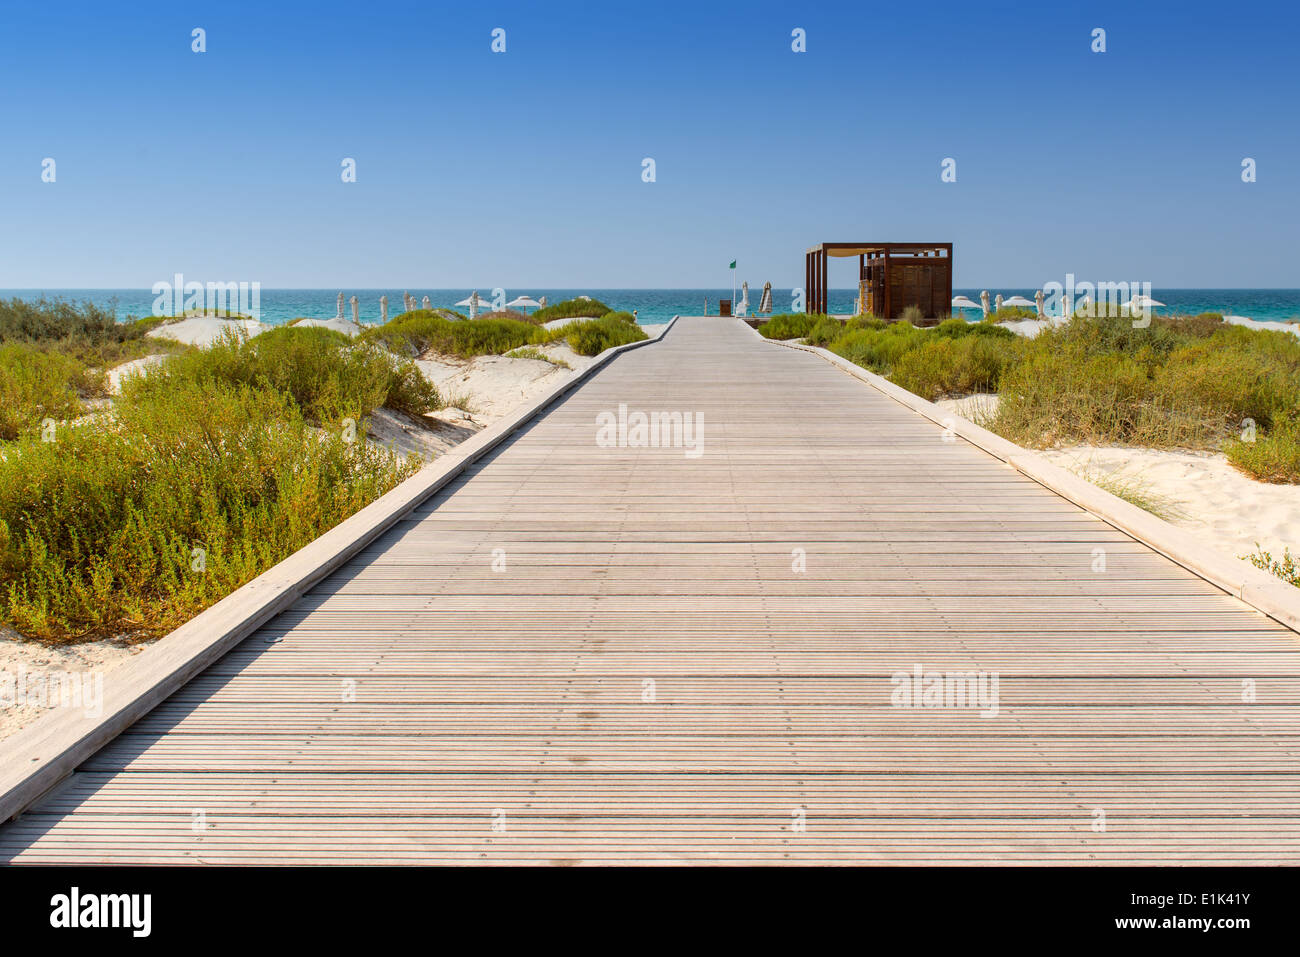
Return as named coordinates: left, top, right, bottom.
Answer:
left=0, top=377, right=420, bottom=641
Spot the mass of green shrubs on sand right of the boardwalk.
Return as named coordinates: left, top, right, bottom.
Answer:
left=818, top=313, right=1300, bottom=482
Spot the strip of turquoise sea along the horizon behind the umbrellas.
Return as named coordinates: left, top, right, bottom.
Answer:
left=0, top=287, right=1300, bottom=324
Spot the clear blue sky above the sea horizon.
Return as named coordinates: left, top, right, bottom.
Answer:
left=0, top=0, right=1300, bottom=289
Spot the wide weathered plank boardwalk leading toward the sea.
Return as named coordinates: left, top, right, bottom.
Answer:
left=0, top=319, right=1300, bottom=865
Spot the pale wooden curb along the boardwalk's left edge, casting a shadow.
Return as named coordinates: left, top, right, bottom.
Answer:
left=0, top=316, right=676, bottom=822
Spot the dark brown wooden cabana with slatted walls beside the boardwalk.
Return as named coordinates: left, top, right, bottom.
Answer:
left=803, top=243, right=953, bottom=319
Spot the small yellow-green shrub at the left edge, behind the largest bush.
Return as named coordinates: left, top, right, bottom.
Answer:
left=0, top=342, right=104, bottom=439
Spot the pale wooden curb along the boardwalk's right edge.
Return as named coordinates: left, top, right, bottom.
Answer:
left=751, top=321, right=1300, bottom=632
